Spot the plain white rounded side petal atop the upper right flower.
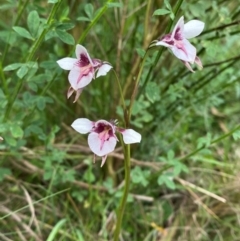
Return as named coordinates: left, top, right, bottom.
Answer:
left=183, top=20, right=205, bottom=39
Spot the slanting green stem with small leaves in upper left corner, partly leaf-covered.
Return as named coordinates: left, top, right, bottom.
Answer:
left=4, top=0, right=62, bottom=121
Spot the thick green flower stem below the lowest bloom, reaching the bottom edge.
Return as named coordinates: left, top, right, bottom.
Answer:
left=114, top=145, right=130, bottom=241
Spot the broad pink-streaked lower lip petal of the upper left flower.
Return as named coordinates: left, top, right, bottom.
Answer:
left=68, top=66, right=94, bottom=90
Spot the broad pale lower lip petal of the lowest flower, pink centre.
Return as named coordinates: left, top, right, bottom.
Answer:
left=88, top=132, right=117, bottom=156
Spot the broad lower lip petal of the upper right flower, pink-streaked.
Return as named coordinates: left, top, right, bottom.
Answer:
left=171, top=39, right=197, bottom=63
